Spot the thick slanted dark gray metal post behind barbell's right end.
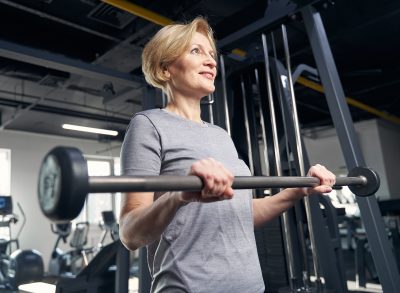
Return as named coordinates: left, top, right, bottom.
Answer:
left=302, top=6, right=400, bottom=293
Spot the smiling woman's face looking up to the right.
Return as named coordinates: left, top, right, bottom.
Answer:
left=165, top=32, right=217, bottom=98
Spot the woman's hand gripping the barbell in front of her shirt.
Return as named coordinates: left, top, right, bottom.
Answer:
left=181, top=158, right=234, bottom=203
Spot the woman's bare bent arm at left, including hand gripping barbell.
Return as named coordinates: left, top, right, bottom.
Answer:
left=120, top=159, right=233, bottom=250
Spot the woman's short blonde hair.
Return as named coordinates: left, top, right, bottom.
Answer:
left=142, top=17, right=217, bottom=99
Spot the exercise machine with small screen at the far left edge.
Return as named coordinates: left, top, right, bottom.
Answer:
left=0, top=196, right=44, bottom=290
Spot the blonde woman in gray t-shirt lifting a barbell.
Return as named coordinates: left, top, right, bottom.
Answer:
left=120, top=18, right=335, bottom=292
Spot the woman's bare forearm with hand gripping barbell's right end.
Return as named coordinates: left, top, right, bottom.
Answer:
left=253, top=164, right=336, bottom=227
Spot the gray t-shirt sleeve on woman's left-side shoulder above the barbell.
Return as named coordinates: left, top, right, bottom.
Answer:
left=121, top=114, right=161, bottom=176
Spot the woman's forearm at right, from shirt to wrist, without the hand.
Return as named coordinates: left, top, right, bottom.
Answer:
left=253, top=188, right=306, bottom=227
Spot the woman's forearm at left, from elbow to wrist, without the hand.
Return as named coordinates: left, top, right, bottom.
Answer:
left=120, top=192, right=182, bottom=250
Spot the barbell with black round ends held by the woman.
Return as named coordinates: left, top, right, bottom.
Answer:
left=38, top=147, right=380, bottom=223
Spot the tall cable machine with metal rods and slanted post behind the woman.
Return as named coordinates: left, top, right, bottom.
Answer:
left=216, top=1, right=400, bottom=293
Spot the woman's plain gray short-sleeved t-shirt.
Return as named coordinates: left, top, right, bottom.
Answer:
left=121, top=109, right=264, bottom=293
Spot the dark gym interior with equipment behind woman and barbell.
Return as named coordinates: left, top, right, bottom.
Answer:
left=0, top=0, right=400, bottom=293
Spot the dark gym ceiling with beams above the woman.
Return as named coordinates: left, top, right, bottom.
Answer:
left=0, top=0, right=400, bottom=140
